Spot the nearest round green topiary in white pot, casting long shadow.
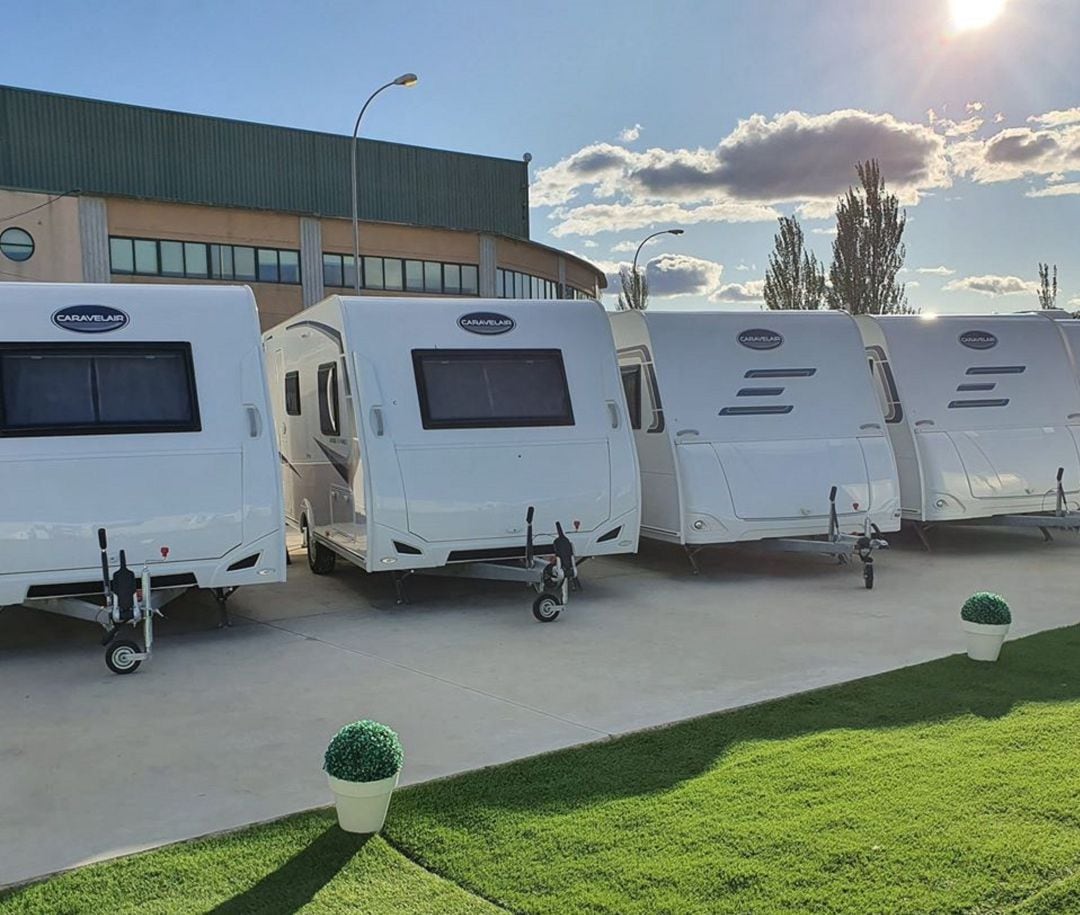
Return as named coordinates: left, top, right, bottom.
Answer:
left=323, top=721, right=405, bottom=833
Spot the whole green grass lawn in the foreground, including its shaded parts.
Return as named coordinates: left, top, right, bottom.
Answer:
left=0, top=627, right=1080, bottom=915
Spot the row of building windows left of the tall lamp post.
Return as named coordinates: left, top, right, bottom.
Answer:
left=109, top=237, right=300, bottom=285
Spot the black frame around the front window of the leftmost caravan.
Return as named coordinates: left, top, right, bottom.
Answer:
left=0, top=340, right=202, bottom=439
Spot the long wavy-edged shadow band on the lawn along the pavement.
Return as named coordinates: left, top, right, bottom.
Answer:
left=390, top=625, right=1080, bottom=821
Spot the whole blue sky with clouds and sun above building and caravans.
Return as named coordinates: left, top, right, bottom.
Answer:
left=0, top=0, right=1080, bottom=313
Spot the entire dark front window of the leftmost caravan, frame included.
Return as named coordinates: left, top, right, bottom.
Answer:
left=0, top=342, right=201, bottom=436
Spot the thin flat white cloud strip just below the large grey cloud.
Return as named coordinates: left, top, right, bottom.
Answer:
left=550, top=202, right=780, bottom=238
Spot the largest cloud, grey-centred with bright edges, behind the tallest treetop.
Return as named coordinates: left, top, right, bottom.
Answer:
left=530, top=109, right=950, bottom=237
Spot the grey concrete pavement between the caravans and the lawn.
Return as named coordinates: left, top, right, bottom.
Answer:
left=0, top=528, right=1080, bottom=885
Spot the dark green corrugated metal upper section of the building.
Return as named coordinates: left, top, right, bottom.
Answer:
left=0, top=86, right=529, bottom=239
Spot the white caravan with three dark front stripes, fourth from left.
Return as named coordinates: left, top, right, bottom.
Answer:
left=856, top=314, right=1080, bottom=544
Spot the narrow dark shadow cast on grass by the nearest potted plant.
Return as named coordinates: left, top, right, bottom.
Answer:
left=208, top=825, right=372, bottom=915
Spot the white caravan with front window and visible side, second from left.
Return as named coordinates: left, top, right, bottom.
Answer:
left=264, top=296, right=638, bottom=621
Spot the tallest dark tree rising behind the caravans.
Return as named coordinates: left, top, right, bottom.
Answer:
left=828, top=159, right=915, bottom=314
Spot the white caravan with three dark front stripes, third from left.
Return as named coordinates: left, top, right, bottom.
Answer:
left=611, top=311, right=900, bottom=588
